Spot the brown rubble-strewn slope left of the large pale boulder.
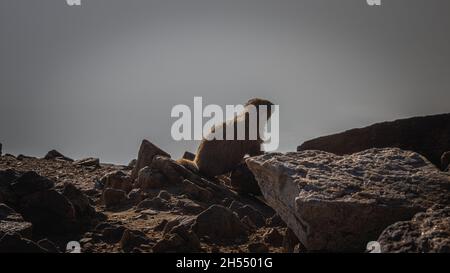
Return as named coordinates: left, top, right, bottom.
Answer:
left=0, top=140, right=288, bottom=252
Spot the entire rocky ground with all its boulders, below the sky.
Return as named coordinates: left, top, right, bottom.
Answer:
left=0, top=114, right=450, bottom=252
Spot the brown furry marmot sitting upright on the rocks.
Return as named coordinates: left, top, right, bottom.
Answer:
left=178, top=98, right=274, bottom=177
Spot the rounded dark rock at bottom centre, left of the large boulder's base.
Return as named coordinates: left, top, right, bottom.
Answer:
left=193, top=205, right=247, bottom=242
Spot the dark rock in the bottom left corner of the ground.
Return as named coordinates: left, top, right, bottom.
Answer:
left=0, top=233, right=46, bottom=253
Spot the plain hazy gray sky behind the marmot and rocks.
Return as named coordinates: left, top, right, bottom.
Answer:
left=0, top=0, right=450, bottom=163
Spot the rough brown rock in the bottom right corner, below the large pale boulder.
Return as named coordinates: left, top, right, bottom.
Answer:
left=377, top=207, right=450, bottom=253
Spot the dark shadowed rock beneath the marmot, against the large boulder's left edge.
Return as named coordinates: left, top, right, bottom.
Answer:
left=230, top=164, right=261, bottom=195
